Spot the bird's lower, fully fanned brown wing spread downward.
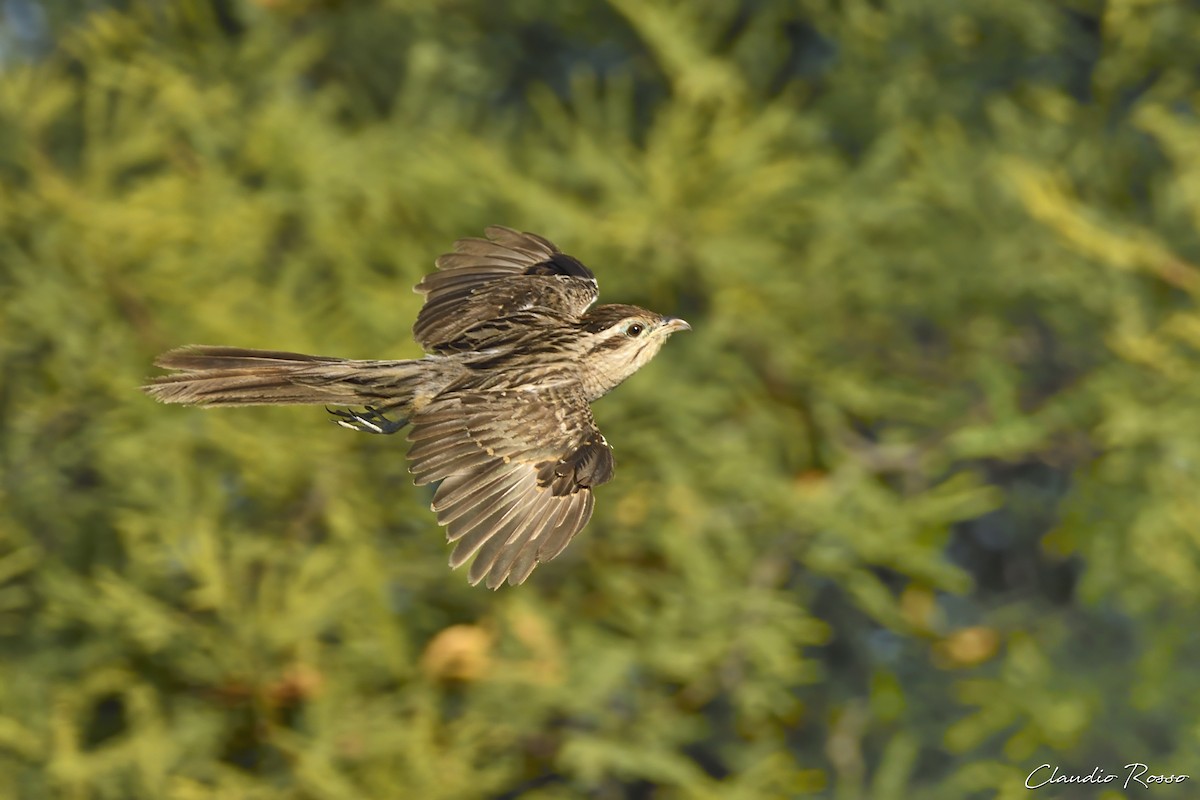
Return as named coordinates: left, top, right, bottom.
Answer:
left=408, top=384, right=613, bottom=589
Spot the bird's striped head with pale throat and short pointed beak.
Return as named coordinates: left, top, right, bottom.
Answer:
left=580, top=303, right=691, bottom=398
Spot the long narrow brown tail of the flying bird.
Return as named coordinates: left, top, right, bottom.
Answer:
left=142, top=345, right=426, bottom=410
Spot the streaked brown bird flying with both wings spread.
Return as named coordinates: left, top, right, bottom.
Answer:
left=142, top=225, right=691, bottom=589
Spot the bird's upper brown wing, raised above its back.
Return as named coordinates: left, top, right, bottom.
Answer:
left=413, top=225, right=599, bottom=353
